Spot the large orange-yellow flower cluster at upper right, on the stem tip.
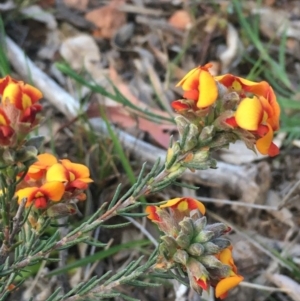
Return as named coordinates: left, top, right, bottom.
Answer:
left=172, top=64, right=280, bottom=156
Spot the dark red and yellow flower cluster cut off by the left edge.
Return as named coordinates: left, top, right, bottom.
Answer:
left=0, top=76, right=43, bottom=147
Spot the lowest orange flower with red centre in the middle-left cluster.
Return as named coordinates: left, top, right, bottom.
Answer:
left=16, top=181, right=65, bottom=209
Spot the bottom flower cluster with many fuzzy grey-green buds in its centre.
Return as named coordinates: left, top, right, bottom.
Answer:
left=146, top=197, right=243, bottom=299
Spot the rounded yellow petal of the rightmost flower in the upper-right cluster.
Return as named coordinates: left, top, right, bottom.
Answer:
left=235, top=96, right=263, bottom=131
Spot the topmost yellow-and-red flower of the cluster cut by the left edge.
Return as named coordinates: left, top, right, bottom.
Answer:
left=0, top=76, right=43, bottom=111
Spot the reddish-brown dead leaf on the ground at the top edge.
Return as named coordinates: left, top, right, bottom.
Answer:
left=85, top=0, right=127, bottom=39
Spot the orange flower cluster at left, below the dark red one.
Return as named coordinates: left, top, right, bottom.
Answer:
left=16, top=153, right=92, bottom=215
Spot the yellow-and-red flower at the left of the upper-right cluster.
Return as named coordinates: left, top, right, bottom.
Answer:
left=172, top=64, right=218, bottom=111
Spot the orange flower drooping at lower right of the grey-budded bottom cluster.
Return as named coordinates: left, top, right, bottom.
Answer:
left=215, top=248, right=244, bottom=299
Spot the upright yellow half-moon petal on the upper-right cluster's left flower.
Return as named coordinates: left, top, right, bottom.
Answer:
left=197, top=70, right=218, bottom=109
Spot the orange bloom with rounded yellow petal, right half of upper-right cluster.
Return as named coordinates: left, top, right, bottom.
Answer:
left=215, top=74, right=280, bottom=156
